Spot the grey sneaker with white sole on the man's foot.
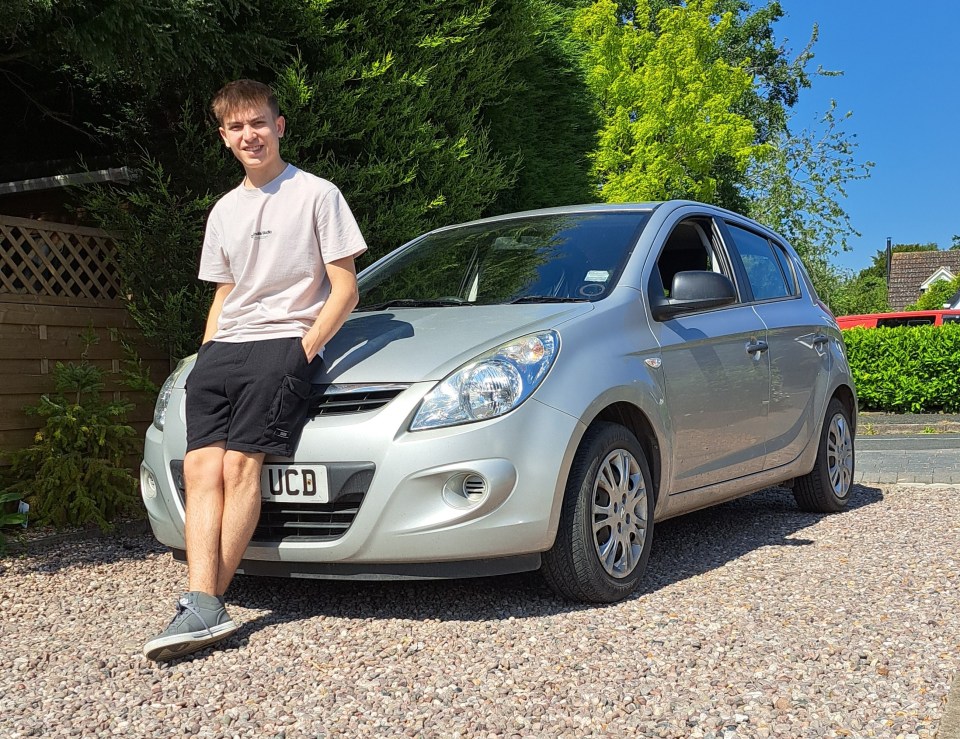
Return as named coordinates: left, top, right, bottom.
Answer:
left=143, top=592, right=237, bottom=661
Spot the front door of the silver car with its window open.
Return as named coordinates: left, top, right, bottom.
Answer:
left=648, top=217, right=770, bottom=494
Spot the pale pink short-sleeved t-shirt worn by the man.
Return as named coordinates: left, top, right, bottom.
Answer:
left=199, top=164, right=367, bottom=342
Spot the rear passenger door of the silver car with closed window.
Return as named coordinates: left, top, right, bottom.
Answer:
left=722, top=221, right=829, bottom=469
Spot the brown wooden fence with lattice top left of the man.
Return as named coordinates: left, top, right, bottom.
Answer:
left=0, top=215, right=170, bottom=465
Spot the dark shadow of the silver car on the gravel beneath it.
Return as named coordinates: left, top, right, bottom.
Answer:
left=221, top=485, right=883, bottom=638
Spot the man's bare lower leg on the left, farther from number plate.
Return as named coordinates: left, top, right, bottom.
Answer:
left=183, top=442, right=226, bottom=595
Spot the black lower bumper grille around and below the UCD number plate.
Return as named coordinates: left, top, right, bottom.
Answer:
left=170, top=459, right=375, bottom=544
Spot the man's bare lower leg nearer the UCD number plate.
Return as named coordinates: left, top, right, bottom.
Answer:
left=214, top=451, right=264, bottom=595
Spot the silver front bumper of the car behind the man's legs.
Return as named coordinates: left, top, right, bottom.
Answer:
left=141, top=383, right=585, bottom=578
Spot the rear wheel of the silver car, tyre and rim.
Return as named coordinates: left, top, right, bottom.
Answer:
left=793, top=398, right=854, bottom=513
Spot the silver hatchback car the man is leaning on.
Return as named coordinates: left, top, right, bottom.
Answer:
left=141, top=201, right=857, bottom=602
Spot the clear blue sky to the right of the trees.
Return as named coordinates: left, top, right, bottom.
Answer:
left=772, top=0, right=960, bottom=270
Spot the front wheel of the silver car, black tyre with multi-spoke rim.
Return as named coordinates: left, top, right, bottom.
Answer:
left=542, top=423, right=654, bottom=603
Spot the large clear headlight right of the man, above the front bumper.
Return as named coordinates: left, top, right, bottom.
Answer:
left=410, top=331, right=560, bottom=431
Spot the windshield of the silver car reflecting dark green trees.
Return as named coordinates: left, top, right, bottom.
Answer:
left=357, top=211, right=649, bottom=311
